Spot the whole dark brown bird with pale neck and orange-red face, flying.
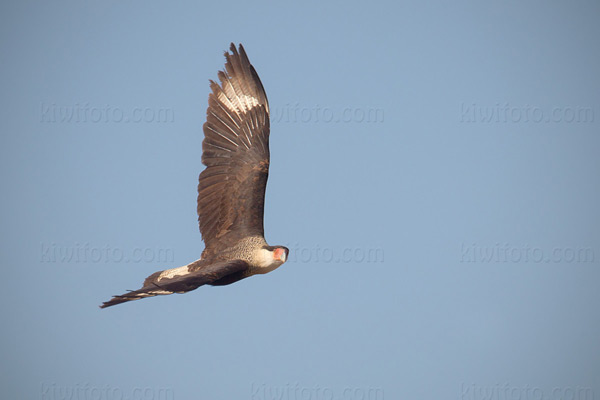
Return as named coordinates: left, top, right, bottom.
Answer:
left=100, top=43, right=289, bottom=308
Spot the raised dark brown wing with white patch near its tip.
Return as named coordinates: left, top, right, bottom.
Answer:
left=198, top=43, right=269, bottom=258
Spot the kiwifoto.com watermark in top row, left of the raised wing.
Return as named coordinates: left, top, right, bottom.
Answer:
left=39, top=102, right=175, bottom=124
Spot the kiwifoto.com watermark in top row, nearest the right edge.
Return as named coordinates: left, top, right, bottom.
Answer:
left=459, top=102, right=595, bottom=124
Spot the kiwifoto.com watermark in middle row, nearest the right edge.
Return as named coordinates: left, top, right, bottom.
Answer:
left=460, top=243, right=596, bottom=264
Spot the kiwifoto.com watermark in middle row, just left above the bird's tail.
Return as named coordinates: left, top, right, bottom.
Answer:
left=40, top=242, right=175, bottom=264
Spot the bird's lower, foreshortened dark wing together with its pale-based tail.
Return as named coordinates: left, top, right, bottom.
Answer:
left=100, top=260, right=248, bottom=308
